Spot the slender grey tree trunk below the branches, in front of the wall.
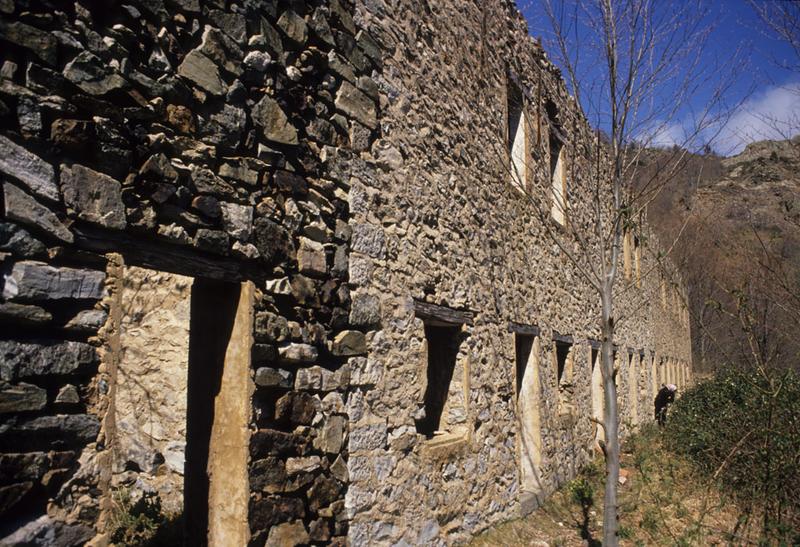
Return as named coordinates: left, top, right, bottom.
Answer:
left=600, top=279, right=619, bottom=547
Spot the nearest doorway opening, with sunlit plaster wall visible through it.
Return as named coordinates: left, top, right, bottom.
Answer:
left=111, top=267, right=253, bottom=546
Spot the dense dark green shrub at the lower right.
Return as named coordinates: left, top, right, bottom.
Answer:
left=665, top=370, right=800, bottom=543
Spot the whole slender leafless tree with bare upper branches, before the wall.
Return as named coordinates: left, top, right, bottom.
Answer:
left=510, top=0, right=752, bottom=546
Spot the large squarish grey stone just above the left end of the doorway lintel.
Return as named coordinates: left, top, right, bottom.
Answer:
left=61, top=165, right=125, bottom=230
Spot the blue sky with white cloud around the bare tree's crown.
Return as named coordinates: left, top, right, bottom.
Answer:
left=517, top=0, right=800, bottom=155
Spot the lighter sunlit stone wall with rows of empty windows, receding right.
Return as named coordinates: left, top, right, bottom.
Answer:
left=346, top=0, right=690, bottom=545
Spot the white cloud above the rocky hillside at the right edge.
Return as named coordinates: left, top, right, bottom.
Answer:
left=713, top=83, right=800, bottom=155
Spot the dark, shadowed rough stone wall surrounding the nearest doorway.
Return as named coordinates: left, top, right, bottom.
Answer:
left=0, top=0, right=380, bottom=545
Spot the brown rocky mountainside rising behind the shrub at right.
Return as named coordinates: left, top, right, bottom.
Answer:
left=649, top=137, right=800, bottom=374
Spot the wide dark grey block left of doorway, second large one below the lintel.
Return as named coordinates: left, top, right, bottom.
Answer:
left=0, top=340, right=97, bottom=381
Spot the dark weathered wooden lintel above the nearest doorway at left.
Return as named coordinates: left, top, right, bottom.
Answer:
left=73, top=225, right=245, bottom=281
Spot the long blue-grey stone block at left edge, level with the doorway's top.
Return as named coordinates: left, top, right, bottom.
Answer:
left=3, top=260, right=106, bottom=301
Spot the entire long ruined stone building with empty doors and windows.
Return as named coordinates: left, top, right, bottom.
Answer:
left=0, top=0, right=691, bottom=545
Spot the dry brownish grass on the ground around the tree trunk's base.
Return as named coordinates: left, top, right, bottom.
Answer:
left=471, top=427, right=755, bottom=547
